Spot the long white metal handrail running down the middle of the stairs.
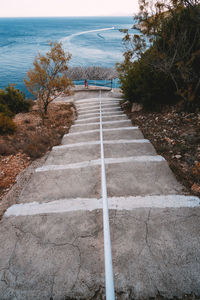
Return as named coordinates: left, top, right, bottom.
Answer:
left=99, top=90, right=115, bottom=300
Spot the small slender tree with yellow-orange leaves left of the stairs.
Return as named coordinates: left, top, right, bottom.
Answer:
left=24, top=42, right=73, bottom=118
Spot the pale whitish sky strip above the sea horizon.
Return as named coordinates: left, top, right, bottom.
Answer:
left=0, top=0, right=138, bottom=17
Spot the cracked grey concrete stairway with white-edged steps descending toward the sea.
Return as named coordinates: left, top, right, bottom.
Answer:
left=0, top=92, right=200, bottom=300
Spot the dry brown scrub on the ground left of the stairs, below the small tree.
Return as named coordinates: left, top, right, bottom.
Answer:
left=0, top=103, right=74, bottom=159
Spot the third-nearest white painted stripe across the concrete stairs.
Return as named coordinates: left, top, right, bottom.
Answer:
left=52, top=139, right=150, bottom=150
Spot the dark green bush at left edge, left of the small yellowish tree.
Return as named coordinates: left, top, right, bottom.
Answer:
left=0, top=85, right=31, bottom=117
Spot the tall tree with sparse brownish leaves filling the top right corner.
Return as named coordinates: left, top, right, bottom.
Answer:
left=117, top=0, right=200, bottom=107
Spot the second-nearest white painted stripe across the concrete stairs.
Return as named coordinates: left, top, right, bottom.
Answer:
left=35, top=155, right=165, bottom=172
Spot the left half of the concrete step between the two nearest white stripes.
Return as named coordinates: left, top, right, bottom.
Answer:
left=19, top=165, right=101, bottom=203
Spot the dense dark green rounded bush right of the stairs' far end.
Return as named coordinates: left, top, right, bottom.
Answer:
left=120, top=50, right=178, bottom=110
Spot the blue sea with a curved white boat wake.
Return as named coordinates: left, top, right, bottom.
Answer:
left=0, top=17, right=136, bottom=94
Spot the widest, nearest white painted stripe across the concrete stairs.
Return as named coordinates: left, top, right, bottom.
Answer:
left=4, top=195, right=200, bottom=217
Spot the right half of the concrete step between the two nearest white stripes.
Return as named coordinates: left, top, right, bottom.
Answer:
left=106, top=162, right=183, bottom=197
